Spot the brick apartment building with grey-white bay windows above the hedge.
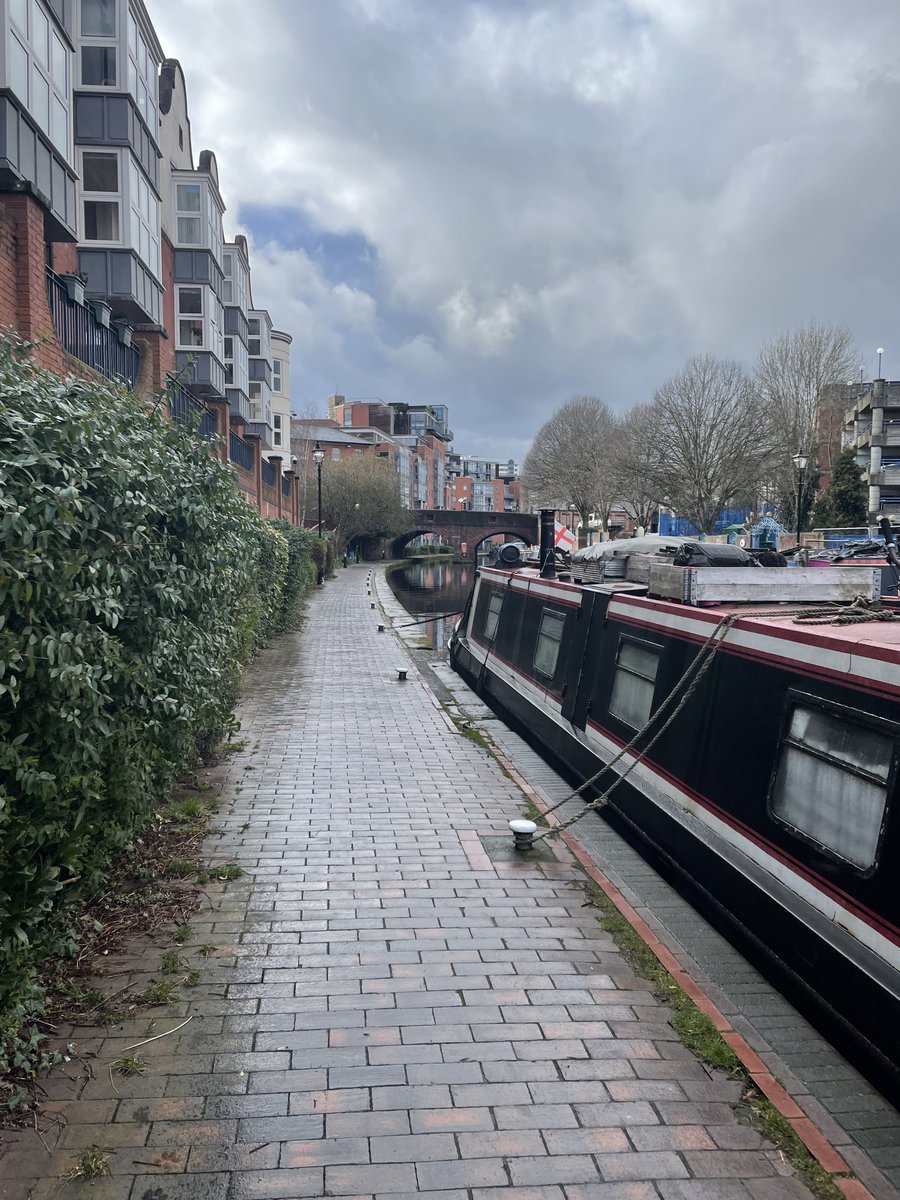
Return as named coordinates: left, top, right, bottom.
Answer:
left=0, top=0, right=299, bottom=521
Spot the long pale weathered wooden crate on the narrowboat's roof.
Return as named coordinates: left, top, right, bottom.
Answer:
left=648, top=563, right=881, bottom=605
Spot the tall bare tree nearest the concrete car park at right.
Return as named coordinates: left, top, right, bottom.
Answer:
left=756, top=322, right=859, bottom=528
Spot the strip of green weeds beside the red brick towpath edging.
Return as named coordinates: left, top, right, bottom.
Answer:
left=584, top=883, right=852, bottom=1200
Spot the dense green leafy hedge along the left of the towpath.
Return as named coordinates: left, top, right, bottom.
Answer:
left=0, top=338, right=318, bottom=1041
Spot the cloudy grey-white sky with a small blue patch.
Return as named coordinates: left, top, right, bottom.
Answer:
left=148, top=0, right=900, bottom=462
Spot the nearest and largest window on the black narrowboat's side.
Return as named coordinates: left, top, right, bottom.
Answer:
left=769, top=704, right=896, bottom=871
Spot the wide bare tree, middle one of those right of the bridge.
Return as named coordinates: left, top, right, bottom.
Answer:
left=647, top=355, right=772, bottom=533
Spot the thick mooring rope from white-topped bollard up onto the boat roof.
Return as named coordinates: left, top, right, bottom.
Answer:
left=534, top=595, right=900, bottom=841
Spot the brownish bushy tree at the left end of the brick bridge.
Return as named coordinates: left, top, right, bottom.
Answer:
left=322, top=454, right=412, bottom=554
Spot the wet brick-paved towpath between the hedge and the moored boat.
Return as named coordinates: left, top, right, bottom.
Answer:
left=0, top=568, right=873, bottom=1200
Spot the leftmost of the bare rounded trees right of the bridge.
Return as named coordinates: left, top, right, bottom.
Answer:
left=522, top=396, right=618, bottom=532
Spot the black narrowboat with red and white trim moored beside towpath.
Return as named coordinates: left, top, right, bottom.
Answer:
left=450, top=539, right=900, bottom=1103
